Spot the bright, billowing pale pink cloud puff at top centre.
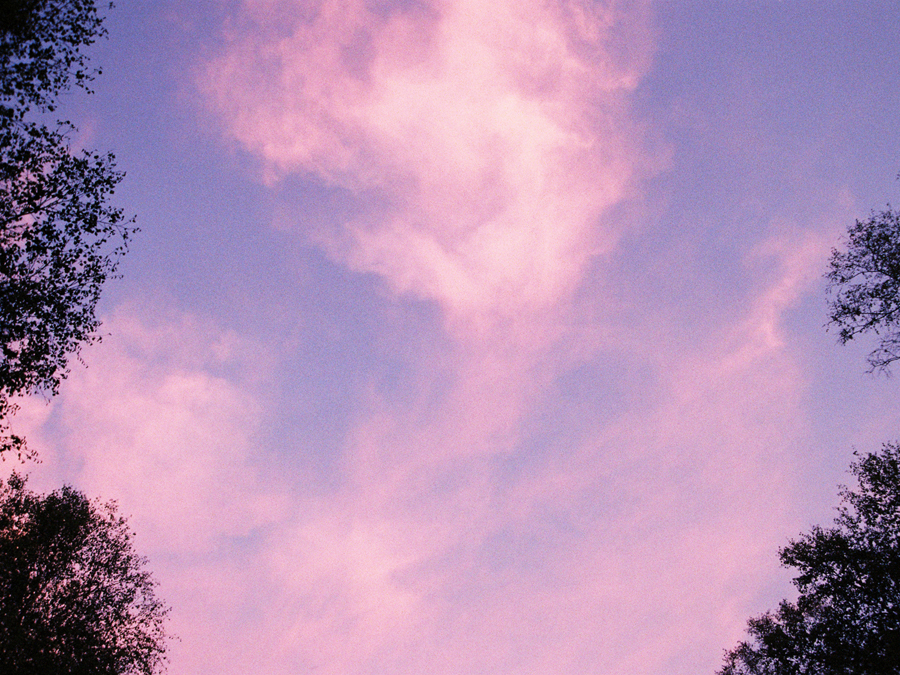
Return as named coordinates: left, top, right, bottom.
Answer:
left=202, top=0, right=650, bottom=317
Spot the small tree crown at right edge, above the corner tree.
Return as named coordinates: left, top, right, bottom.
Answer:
left=828, top=206, right=900, bottom=370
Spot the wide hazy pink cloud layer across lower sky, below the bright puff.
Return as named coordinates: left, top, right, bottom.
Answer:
left=0, top=230, right=864, bottom=675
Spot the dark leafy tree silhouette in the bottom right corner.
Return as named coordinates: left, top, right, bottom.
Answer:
left=719, top=443, right=900, bottom=675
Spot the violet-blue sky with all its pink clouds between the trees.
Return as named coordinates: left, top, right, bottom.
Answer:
left=2, top=0, right=900, bottom=675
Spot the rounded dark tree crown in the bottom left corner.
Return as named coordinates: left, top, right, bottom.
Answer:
left=0, top=474, right=168, bottom=675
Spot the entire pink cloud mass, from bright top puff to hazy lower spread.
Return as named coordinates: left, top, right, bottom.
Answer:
left=7, top=5, right=872, bottom=675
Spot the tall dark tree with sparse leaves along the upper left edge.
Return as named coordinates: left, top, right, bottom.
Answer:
left=0, top=0, right=134, bottom=454
